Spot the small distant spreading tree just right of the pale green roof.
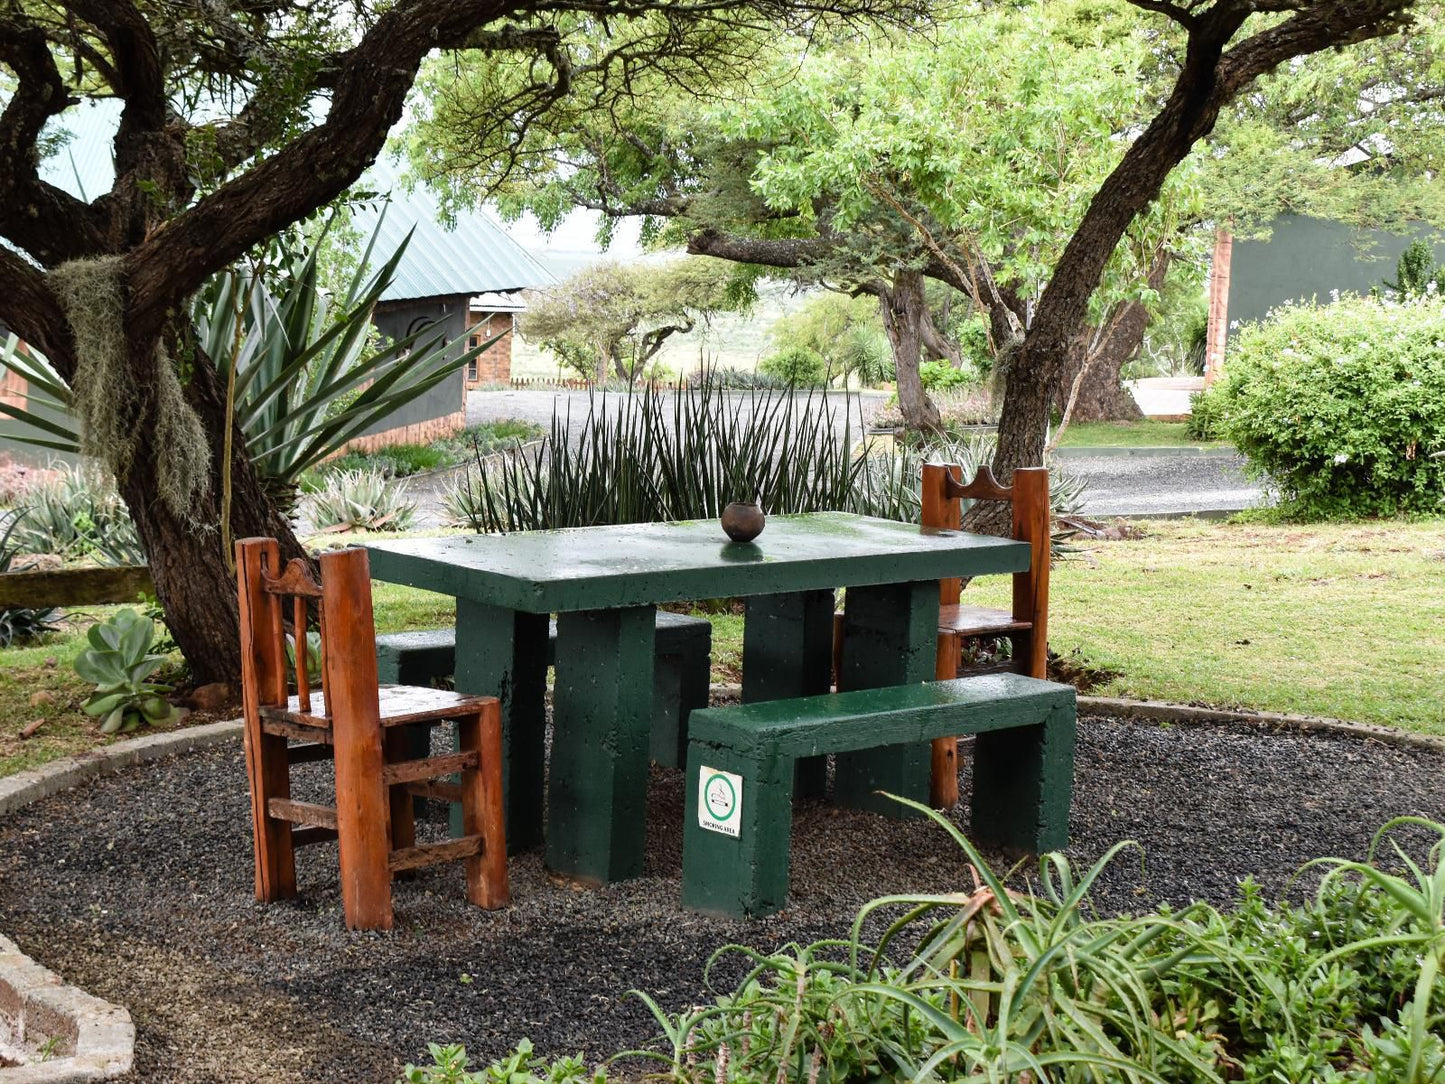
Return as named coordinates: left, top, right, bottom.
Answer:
left=519, top=259, right=754, bottom=383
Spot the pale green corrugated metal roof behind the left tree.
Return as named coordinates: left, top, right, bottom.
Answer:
left=40, top=100, right=556, bottom=301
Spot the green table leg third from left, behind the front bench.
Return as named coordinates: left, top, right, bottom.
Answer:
left=743, top=590, right=834, bottom=798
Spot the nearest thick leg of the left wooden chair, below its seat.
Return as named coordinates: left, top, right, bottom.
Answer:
left=328, top=708, right=392, bottom=929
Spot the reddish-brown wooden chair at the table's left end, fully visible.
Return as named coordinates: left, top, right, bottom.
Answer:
left=236, top=538, right=510, bottom=929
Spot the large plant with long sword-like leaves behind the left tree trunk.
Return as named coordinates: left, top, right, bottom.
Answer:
left=0, top=223, right=500, bottom=507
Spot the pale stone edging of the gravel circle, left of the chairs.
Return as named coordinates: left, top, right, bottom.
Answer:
left=0, top=720, right=241, bottom=1084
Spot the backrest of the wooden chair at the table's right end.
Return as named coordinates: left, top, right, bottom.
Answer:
left=919, top=463, right=1051, bottom=678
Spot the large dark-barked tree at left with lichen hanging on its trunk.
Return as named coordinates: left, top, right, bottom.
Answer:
left=0, top=0, right=909, bottom=681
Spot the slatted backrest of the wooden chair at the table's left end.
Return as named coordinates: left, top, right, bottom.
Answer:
left=236, top=538, right=377, bottom=718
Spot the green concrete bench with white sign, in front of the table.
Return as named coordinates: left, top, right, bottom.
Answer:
left=682, top=674, right=1075, bottom=918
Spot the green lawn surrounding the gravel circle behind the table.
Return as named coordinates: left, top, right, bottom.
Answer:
left=0, top=519, right=1445, bottom=775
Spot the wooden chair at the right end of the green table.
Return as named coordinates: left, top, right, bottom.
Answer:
left=919, top=463, right=1051, bottom=809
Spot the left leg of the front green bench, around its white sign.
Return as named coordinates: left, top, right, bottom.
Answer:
left=682, top=741, right=793, bottom=918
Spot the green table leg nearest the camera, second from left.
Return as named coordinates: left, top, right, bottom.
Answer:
left=546, top=606, right=656, bottom=883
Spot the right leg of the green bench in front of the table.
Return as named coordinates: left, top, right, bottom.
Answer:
left=972, top=704, right=1075, bottom=854
